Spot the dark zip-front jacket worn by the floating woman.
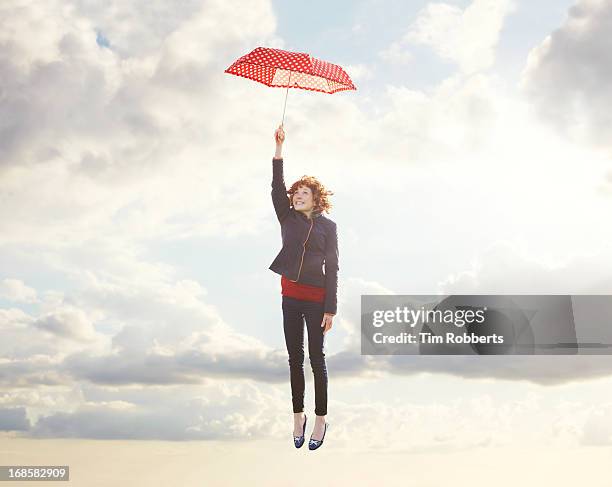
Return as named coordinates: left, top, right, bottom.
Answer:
left=269, top=158, right=340, bottom=314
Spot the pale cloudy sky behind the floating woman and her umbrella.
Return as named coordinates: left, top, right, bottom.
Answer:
left=0, top=0, right=612, bottom=485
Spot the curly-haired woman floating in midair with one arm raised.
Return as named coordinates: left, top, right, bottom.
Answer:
left=270, top=125, right=339, bottom=450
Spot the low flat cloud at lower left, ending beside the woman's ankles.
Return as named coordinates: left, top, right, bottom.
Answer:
left=29, top=382, right=286, bottom=440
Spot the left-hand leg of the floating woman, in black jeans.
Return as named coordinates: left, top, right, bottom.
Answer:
left=283, top=296, right=305, bottom=413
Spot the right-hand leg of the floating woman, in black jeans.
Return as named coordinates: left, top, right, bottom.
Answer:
left=303, top=301, right=327, bottom=416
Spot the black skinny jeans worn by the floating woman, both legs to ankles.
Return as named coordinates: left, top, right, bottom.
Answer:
left=283, top=296, right=327, bottom=416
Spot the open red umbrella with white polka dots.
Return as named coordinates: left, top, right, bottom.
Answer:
left=225, top=47, right=357, bottom=125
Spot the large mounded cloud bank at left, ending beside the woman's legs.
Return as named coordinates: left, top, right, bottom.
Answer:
left=0, top=236, right=287, bottom=387
